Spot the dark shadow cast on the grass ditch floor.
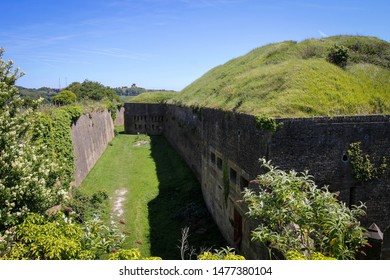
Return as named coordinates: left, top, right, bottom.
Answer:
left=148, top=136, right=228, bottom=260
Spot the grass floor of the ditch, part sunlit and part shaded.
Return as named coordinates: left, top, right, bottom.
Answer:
left=80, top=128, right=227, bottom=259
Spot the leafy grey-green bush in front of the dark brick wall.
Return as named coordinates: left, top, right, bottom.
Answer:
left=244, top=159, right=367, bottom=259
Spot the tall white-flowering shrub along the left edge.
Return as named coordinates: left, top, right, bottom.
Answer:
left=0, top=49, right=69, bottom=231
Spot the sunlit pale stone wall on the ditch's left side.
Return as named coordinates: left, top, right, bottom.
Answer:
left=71, top=111, right=114, bottom=186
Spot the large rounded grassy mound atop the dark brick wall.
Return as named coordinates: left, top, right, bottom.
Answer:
left=138, top=36, right=390, bottom=117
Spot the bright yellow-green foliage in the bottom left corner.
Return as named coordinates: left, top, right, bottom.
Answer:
left=0, top=213, right=123, bottom=260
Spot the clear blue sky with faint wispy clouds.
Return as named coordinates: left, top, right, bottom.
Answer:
left=0, top=0, right=390, bottom=90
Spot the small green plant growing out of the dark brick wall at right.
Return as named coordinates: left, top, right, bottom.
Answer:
left=348, top=142, right=387, bottom=182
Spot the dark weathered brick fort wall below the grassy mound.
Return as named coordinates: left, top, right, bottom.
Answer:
left=125, top=104, right=390, bottom=258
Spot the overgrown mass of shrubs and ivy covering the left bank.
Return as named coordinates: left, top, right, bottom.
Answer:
left=0, top=47, right=123, bottom=259
